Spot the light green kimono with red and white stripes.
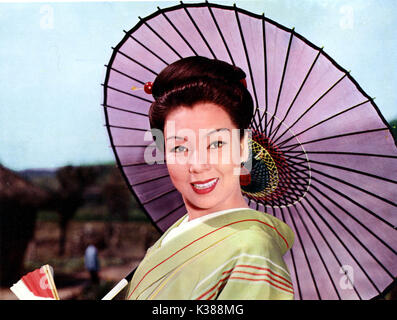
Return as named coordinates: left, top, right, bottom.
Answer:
left=126, top=209, right=294, bottom=300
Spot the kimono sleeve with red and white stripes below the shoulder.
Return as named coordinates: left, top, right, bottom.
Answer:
left=213, top=231, right=294, bottom=300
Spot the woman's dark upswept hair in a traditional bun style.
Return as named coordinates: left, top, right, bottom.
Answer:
left=149, top=56, right=254, bottom=137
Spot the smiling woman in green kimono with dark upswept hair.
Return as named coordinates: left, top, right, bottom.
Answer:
left=127, top=57, right=293, bottom=299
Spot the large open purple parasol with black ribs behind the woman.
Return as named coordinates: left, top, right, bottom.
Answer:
left=103, top=2, right=397, bottom=299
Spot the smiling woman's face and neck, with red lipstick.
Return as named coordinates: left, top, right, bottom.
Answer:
left=164, top=103, right=245, bottom=215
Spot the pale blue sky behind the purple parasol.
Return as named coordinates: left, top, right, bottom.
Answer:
left=0, top=0, right=397, bottom=170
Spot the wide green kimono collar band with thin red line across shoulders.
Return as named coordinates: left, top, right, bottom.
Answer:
left=128, top=209, right=293, bottom=298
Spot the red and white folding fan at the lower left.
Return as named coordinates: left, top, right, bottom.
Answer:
left=10, top=264, right=59, bottom=300
